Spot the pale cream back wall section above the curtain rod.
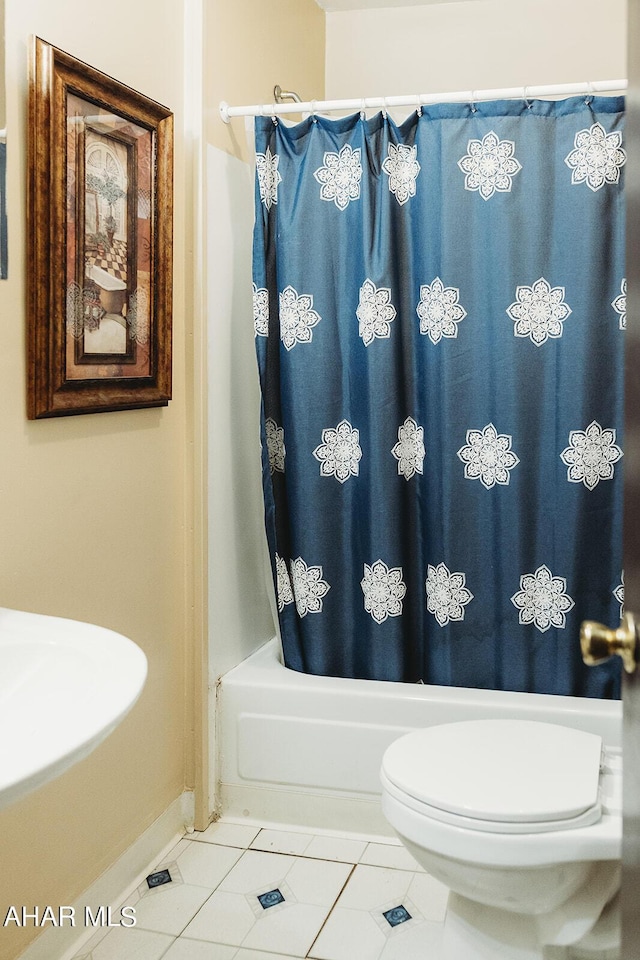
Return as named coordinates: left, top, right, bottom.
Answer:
left=326, top=0, right=626, bottom=99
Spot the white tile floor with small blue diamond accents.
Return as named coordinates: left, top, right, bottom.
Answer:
left=76, top=821, right=447, bottom=960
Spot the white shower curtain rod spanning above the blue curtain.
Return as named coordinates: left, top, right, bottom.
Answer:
left=219, top=80, right=627, bottom=123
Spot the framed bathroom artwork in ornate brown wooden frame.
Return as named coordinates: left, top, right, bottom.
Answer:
left=28, top=38, right=173, bottom=420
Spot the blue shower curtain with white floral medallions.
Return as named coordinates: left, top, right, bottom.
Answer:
left=254, top=97, right=626, bottom=697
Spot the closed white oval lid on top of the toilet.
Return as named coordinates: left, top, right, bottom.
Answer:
left=382, top=720, right=602, bottom=823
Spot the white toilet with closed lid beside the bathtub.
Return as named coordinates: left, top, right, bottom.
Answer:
left=381, top=720, right=622, bottom=960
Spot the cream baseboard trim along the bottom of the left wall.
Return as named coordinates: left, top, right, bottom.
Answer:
left=19, top=791, right=194, bottom=960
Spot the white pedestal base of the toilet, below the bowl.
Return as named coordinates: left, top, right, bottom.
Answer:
left=442, top=861, right=619, bottom=960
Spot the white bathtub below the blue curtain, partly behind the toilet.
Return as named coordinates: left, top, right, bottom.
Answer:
left=217, top=639, right=622, bottom=834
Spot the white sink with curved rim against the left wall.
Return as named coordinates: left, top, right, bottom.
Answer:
left=0, top=607, right=147, bottom=807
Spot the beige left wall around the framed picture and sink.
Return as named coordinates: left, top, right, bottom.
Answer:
left=0, top=0, right=192, bottom=960
